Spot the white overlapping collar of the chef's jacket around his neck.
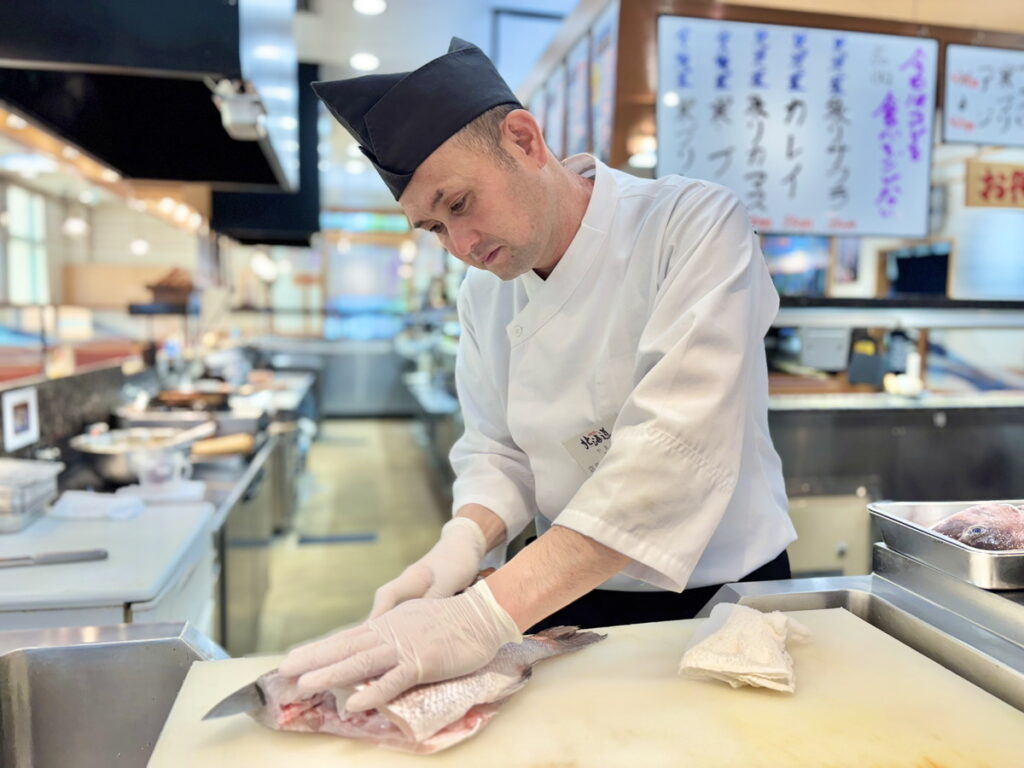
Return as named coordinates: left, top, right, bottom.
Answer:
left=508, top=155, right=618, bottom=345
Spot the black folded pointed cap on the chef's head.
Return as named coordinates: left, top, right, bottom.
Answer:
left=312, top=37, right=521, bottom=200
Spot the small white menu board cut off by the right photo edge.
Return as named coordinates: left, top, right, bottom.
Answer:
left=943, top=45, right=1024, bottom=146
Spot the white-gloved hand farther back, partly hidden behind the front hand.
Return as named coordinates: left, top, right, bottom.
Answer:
left=370, top=517, right=487, bottom=618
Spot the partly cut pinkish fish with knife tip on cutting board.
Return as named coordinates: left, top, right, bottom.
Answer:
left=207, top=627, right=605, bottom=755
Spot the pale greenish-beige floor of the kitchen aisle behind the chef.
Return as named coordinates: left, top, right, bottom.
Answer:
left=259, top=419, right=449, bottom=652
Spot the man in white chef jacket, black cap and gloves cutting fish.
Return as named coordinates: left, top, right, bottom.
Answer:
left=281, top=38, right=796, bottom=711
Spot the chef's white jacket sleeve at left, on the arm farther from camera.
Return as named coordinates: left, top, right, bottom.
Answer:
left=449, top=285, right=537, bottom=540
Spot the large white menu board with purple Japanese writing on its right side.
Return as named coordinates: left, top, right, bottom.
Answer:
left=656, top=16, right=938, bottom=237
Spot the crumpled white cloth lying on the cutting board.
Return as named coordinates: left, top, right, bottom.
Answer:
left=679, top=603, right=811, bottom=693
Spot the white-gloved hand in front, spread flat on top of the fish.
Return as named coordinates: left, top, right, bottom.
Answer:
left=278, top=582, right=522, bottom=712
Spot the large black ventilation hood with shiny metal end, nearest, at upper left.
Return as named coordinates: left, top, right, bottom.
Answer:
left=0, top=0, right=299, bottom=191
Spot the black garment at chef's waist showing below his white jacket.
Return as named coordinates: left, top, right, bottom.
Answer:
left=526, top=550, right=791, bottom=634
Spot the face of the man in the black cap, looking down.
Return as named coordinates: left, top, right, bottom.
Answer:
left=398, top=138, right=554, bottom=280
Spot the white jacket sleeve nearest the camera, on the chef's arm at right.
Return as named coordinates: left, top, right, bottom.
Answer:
left=554, top=184, right=778, bottom=591
